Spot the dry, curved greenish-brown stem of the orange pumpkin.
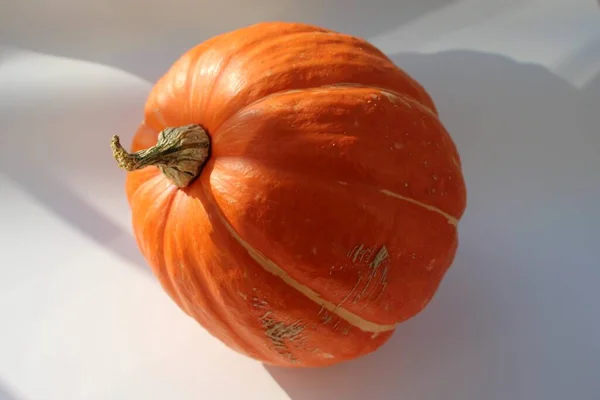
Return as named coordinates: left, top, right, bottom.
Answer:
left=111, top=125, right=210, bottom=188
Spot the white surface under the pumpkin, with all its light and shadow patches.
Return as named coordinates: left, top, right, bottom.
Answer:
left=0, top=0, right=600, bottom=400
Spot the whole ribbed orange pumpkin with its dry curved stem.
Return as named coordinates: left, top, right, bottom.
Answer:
left=112, top=22, right=466, bottom=367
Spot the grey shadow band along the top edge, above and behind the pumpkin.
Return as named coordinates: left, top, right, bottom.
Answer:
left=0, top=0, right=457, bottom=82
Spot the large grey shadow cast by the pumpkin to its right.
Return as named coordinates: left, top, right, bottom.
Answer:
left=266, top=51, right=600, bottom=400
